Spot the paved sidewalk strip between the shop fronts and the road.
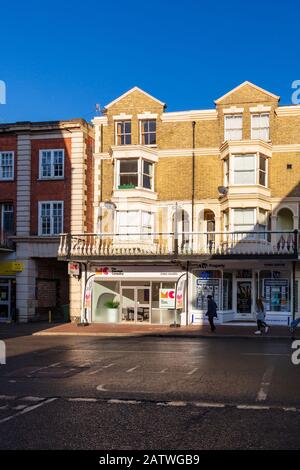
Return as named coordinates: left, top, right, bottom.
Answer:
left=0, top=322, right=300, bottom=339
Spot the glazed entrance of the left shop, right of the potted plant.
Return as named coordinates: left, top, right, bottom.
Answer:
left=121, top=286, right=150, bottom=323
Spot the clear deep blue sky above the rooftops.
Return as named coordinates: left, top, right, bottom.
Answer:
left=0, top=0, right=300, bottom=123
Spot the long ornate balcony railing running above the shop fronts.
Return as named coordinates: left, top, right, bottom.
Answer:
left=58, top=230, right=299, bottom=259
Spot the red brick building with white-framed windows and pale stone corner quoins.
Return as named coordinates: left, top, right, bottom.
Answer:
left=0, top=119, right=93, bottom=321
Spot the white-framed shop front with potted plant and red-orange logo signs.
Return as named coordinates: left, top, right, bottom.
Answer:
left=85, top=266, right=183, bottom=325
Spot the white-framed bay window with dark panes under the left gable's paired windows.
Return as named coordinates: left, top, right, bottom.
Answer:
left=116, top=158, right=153, bottom=191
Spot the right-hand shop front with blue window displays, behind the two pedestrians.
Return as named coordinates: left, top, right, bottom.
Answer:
left=189, top=261, right=297, bottom=325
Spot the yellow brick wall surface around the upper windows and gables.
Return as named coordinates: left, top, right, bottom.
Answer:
left=97, top=86, right=300, bottom=201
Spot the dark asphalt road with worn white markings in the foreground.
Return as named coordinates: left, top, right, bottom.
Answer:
left=0, top=336, right=300, bottom=450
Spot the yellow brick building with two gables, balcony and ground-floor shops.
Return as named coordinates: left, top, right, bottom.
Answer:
left=59, top=82, right=300, bottom=324
